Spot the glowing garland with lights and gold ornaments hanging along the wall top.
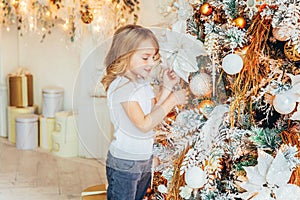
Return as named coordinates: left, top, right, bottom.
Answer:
left=0, top=0, right=139, bottom=41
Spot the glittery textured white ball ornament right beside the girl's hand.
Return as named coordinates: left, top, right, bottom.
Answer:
left=190, top=73, right=212, bottom=96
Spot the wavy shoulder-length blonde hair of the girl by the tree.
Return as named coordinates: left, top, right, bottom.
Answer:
left=101, top=25, right=159, bottom=91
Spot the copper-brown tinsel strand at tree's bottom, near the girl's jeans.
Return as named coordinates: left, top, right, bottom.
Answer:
left=167, top=146, right=190, bottom=200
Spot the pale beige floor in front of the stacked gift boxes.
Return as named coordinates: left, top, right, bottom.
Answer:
left=0, top=137, right=106, bottom=200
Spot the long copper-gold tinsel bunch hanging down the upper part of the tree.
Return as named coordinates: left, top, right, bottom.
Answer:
left=230, top=13, right=271, bottom=126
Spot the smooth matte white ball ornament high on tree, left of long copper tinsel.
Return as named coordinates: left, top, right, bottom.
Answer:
left=222, top=54, right=244, bottom=75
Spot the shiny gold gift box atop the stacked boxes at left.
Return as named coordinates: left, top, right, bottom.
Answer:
left=8, top=74, right=34, bottom=107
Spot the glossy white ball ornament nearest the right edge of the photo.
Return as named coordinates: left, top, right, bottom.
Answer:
left=273, top=92, right=296, bottom=114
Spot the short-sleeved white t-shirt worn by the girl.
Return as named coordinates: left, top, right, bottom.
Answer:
left=107, top=76, right=154, bottom=160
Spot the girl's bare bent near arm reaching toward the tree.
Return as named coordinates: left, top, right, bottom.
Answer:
left=122, top=90, right=187, bottom=133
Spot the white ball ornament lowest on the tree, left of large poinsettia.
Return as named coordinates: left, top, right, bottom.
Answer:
left=185, top=166, right=206, bottom=188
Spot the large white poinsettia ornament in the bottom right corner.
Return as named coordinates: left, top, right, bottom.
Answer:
left=239, top=150, right=300, bottom=200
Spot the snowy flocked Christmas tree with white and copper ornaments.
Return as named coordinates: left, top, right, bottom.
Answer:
left=147, top=0, right=300, bottom=200
